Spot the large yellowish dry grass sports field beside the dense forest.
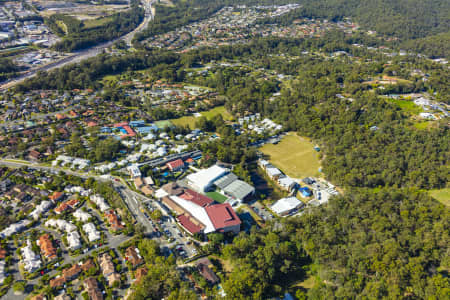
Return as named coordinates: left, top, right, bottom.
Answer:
left=260, top=132, right=320, bottom=178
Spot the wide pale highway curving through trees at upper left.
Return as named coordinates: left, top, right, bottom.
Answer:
left=0, top=0, right=157, bottom=90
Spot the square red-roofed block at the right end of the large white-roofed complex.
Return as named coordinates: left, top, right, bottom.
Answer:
left=205, top=203, right=241, bottom=233
